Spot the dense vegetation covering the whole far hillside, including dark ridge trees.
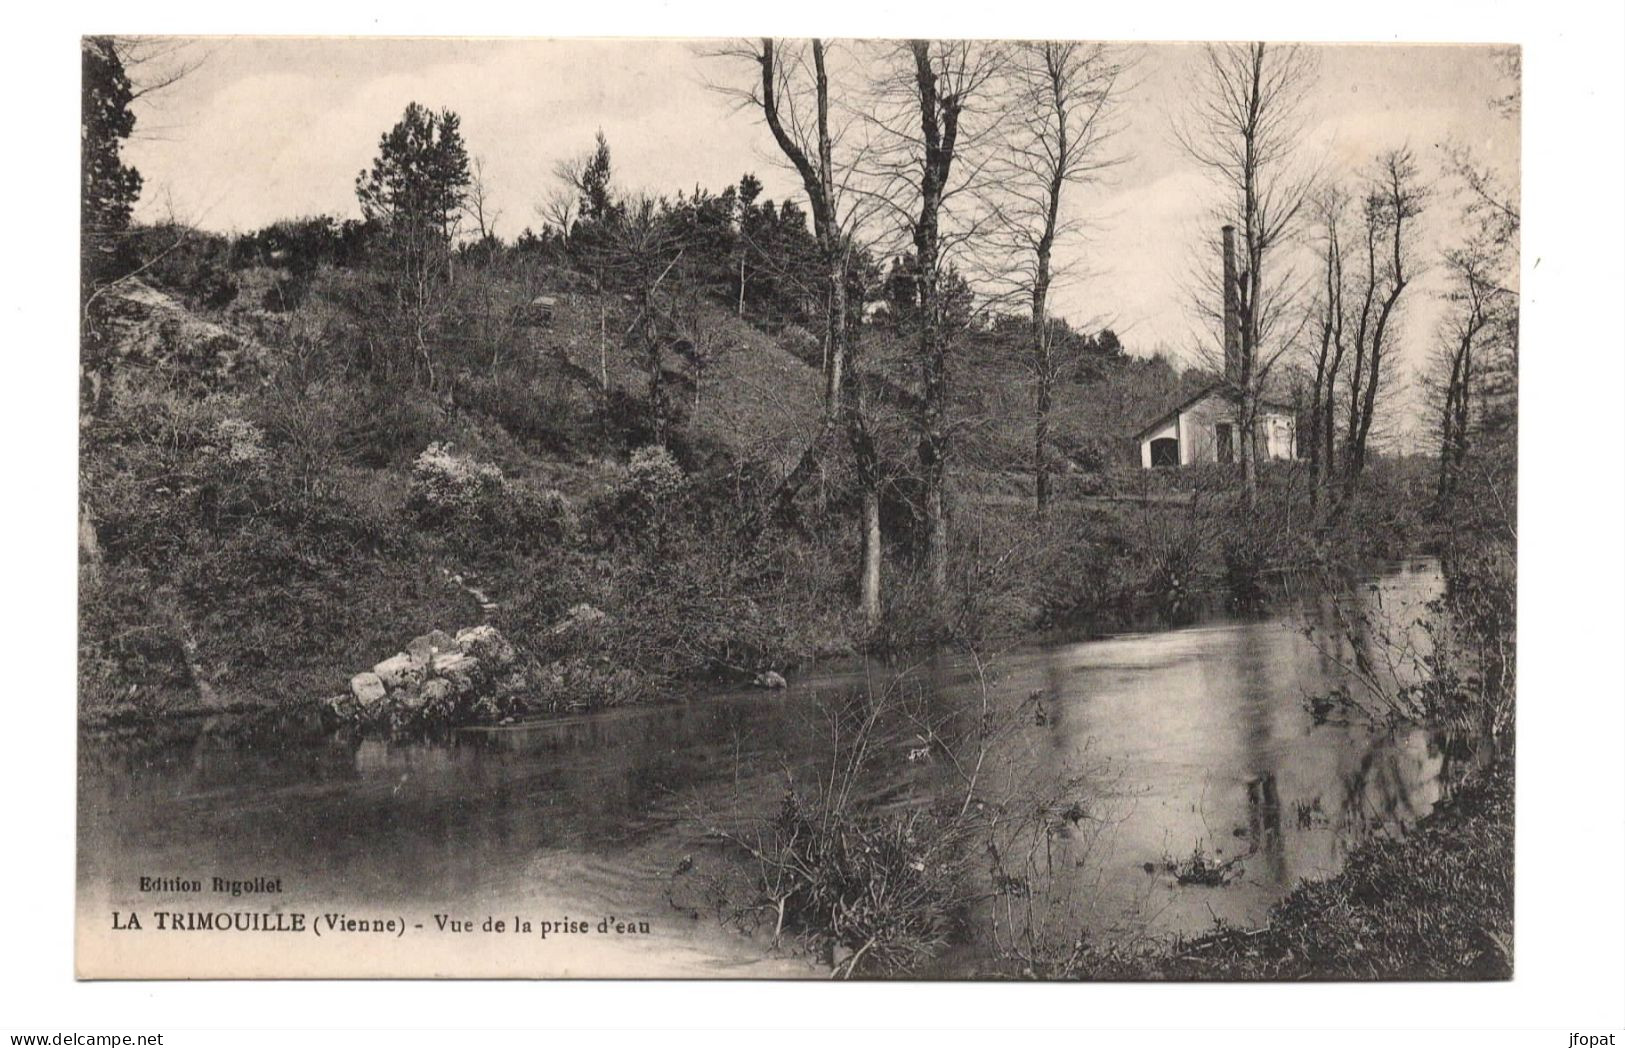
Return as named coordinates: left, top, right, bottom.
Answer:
left=69, top=38, right=1500, bottom=727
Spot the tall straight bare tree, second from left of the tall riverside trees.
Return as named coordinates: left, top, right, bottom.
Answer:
left=865, top=41, right=1006, bottom=606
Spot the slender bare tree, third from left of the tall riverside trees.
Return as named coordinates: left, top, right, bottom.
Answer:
left=996, top=41, right=1123, bottom=513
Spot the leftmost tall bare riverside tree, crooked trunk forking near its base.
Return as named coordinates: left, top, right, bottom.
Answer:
left=720, top=37, right=881, bottom=629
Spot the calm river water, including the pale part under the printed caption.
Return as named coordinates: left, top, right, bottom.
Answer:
left=78, top=561, right=1445, bottom=977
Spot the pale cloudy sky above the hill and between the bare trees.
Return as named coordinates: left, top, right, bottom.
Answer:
left=117, top=37, right=1519, bottom=438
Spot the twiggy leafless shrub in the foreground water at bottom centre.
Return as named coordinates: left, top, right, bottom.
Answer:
left=702, top=678, right=995, bottom=977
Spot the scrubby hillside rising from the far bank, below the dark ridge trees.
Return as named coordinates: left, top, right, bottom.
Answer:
left=80, top=230, right=1436, bottom=718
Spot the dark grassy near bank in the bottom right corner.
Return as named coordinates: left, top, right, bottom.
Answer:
left=1118, top=757, right=1513, bottom=980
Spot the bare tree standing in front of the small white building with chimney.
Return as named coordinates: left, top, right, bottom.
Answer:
left=1175, top=44, right=1316, bottom=502
